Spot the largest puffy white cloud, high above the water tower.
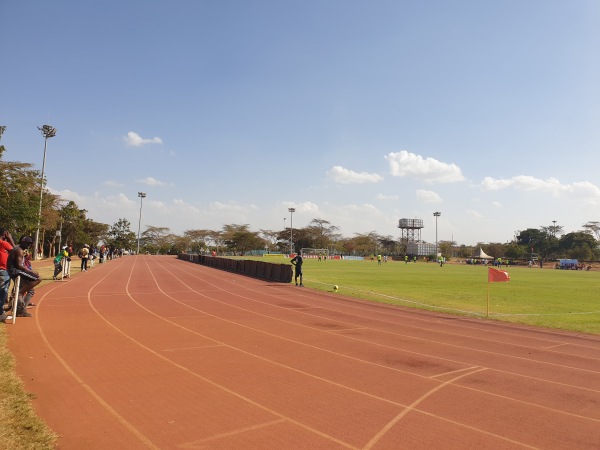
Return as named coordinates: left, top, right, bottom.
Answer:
left=385, top=150, right=465, bottom=183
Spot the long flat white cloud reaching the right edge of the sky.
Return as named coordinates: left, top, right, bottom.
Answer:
left=481, top=175, right=600, bottom=200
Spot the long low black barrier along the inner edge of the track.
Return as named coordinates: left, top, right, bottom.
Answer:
left=177, top=253, right=294, bottom=283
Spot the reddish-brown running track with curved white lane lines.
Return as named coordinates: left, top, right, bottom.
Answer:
left=6, top=256, right=600, bottom=450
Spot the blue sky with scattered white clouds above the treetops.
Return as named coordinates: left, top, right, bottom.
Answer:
left=0, top=0, right=600, bottom=245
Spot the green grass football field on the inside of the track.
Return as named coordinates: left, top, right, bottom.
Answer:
left=278, top=258, right=600, bottom=334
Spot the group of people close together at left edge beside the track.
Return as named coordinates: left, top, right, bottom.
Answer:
left=0, top=229, right=42, bottom=322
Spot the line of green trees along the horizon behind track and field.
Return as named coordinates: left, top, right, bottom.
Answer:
left=0, top=138, right=600, bottom=260
